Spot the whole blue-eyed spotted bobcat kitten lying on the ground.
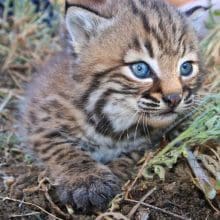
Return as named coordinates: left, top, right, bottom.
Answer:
left=20, top=0, right=202, bottom=213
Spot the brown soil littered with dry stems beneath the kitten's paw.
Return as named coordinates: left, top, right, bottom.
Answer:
left=0, top=106, right=220, bottom=220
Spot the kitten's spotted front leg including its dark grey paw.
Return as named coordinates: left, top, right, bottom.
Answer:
left=38, top=146, right=120, bottom=213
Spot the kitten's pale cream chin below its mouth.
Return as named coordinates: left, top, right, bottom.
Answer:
left=145, top=113, right=177, bottom=128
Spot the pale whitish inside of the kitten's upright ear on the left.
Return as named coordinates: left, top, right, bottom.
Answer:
left=65, top=6, right=110, bottom=53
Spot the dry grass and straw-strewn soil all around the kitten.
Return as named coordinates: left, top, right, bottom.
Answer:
left=0, top=0, right=220, bottom=220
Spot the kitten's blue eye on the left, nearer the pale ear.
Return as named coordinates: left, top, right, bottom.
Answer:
left=131, top=62, right=151, bottom=79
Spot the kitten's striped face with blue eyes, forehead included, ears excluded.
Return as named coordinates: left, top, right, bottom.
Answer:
left=66, top=0, right=204, bottom=131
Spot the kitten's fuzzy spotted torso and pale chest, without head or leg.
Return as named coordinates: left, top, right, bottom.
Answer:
left=22, top=53, right=150, bottom=163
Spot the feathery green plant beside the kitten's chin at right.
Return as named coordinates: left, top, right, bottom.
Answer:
left=143, top=94, right=220, bottom=179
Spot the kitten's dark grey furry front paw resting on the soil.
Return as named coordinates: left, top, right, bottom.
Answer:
left=58, top=170, right=121, bottom=213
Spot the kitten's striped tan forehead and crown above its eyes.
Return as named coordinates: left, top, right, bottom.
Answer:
left=83, top=0, right=198, bottom=71
